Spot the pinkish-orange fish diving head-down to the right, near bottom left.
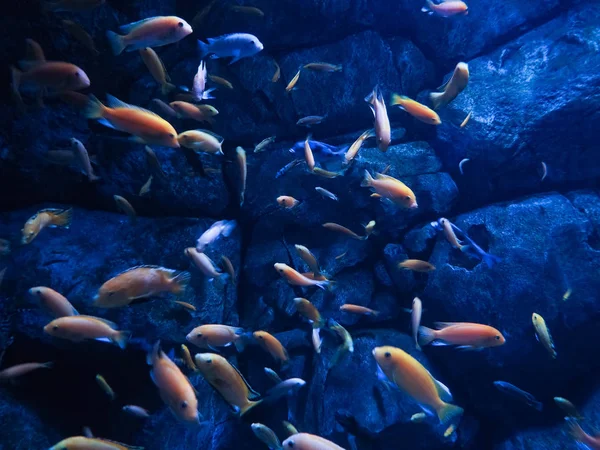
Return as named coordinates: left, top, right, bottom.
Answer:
left=146, top=342, right=201, bottom=423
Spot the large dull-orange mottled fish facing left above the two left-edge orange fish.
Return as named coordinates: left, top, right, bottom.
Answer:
left=94, top=265, right=190, bottom=308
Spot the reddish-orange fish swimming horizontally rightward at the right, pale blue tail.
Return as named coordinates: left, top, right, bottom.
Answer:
left=419, top=322, right=506, bottom=350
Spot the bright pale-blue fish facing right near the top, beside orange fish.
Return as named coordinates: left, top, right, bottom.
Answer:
left=198, top=33, right=264, bottom=64
